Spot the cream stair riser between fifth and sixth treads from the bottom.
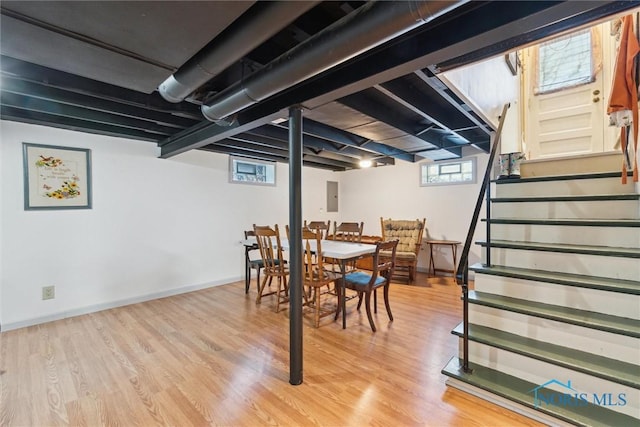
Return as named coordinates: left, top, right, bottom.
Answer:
left=491, top=224, right=640, bottom=248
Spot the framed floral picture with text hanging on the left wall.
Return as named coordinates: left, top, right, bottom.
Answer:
left=22, top=142, right=91, bottom=210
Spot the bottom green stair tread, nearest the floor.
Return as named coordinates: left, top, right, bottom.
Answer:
left=441, top=357, right=638, bottom=426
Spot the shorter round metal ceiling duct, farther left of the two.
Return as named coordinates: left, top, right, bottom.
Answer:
left=158, top=1, right=319, bottom=102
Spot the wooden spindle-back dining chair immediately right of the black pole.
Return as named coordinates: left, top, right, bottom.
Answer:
left=302, top=229, right=342, bottom=328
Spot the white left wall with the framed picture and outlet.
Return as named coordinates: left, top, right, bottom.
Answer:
left=0, top=121, right=339, bottom=330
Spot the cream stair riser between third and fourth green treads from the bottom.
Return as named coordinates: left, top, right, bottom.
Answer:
left=474, top=273, right=640, bottom=320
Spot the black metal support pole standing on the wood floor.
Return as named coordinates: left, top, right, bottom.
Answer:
left=289, top=106, right=302, bottom=385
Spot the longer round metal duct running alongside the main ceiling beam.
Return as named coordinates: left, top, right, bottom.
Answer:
left=202, top=0, right=468, bottom=125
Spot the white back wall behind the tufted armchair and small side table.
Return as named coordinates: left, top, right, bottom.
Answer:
left=340, top=154, right=488, bottom=271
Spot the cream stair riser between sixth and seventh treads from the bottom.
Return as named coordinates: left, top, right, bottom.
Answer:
left=491, top=200, right=640, bottom=219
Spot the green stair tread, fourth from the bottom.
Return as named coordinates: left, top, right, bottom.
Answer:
left=469, top=263, right=640, bottom=295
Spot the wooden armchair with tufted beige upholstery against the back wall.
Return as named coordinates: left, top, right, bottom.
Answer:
left=380, top=218, right=426, bottom=283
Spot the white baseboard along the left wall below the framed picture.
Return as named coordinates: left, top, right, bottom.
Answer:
left=0, top=276, right=244, bottom=332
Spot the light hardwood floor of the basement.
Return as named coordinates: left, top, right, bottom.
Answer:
left=0, top=274, right=539, bottom=426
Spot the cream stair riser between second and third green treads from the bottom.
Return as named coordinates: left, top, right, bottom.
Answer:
left=469, top=304, right=640, bottom=365
